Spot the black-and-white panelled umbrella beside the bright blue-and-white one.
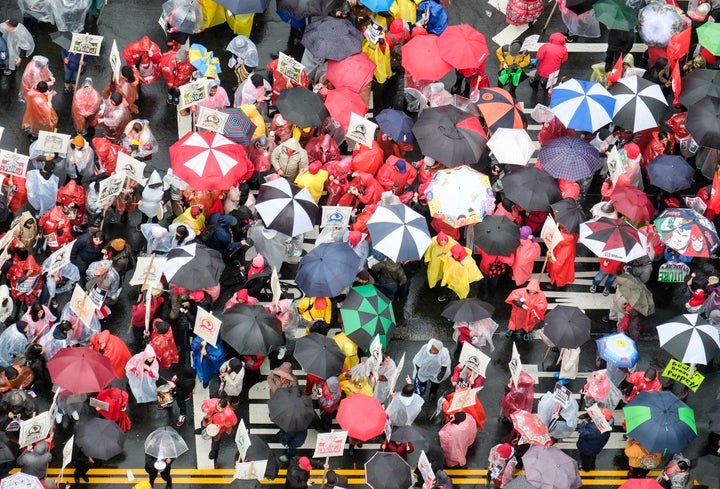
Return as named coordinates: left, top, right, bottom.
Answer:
left=608, top=75, right=667, bottom=132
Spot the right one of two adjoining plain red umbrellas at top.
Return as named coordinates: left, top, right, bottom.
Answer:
left=437, top=24, right=490, bottom=70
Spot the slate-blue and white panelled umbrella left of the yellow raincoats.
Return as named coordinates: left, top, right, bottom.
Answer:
left=367, top=204, right=430, bottom=262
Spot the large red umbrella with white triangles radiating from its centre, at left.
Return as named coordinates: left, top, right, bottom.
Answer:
left=170, top=132, right=253, bottom=190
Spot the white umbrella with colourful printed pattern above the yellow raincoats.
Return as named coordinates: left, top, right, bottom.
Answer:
left=425, top=165, right=495, bottom=228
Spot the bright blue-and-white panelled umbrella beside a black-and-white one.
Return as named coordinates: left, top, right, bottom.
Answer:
left=550, top=79, right=615, bottom=132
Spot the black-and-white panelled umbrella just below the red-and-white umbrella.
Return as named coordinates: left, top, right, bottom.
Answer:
left=255, top=178, right=320, bottom=237
